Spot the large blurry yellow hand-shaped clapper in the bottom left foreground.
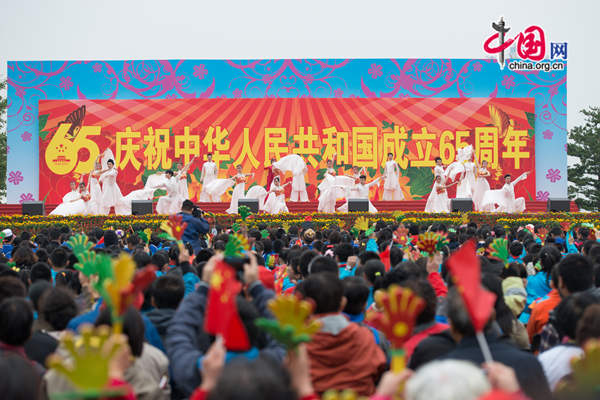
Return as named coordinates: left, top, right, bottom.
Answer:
left=46, top=325, right=128, bottom=399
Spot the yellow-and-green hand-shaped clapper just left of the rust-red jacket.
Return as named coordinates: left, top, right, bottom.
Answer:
left=256, top=295, right=321, bottom=350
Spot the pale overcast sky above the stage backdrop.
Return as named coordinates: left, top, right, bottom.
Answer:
left=0, top=0, right=600, bottom=129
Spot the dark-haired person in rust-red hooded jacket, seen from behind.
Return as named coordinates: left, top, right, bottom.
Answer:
left=297, top=272, right=386, bottom=396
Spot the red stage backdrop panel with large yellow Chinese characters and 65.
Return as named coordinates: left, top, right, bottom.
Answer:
left=39, top=98, right=535, bottom=203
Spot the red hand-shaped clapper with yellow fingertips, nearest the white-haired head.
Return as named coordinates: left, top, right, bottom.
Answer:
left=367, top=285, right=425, bottom=373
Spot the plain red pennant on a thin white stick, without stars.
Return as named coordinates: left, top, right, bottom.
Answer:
left=448, top=240, right=496, bottom=332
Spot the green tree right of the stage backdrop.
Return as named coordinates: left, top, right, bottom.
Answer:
left=567, top=107, right=600, bottom=211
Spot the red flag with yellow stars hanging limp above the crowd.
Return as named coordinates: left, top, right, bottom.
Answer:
left=204, top=261, right=250, bottom=351
